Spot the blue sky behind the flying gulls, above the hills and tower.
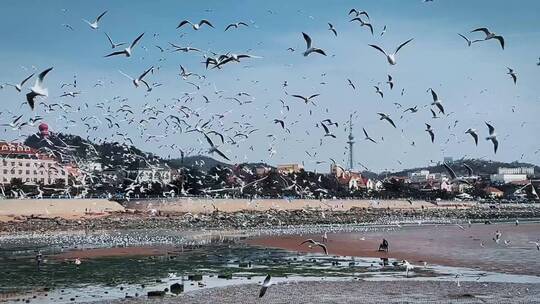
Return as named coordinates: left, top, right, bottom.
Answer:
left=0, top=0, right=540, bottom=171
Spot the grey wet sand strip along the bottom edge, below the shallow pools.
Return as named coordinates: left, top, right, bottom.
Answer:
left=100, top=280, right=540, bottom=304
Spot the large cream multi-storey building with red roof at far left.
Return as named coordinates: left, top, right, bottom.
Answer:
left=0, top=142, right=69, bottom=185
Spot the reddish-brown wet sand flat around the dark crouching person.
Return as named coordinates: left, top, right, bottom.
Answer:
left=246, top=223, right=540, bottom=276
